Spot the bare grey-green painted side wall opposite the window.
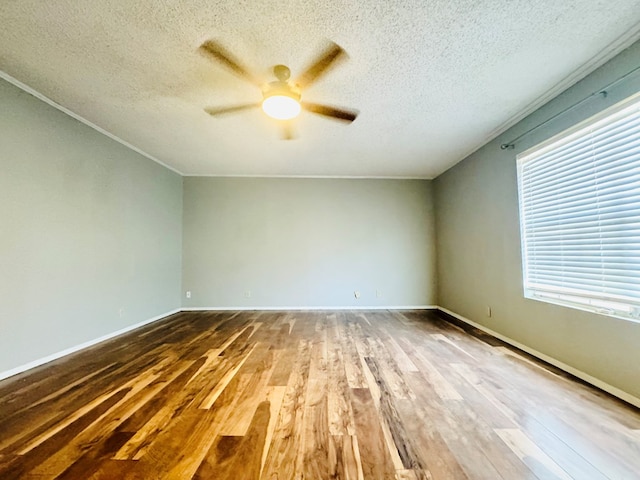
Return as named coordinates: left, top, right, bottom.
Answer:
left=0, top=80, right=182, bottom=372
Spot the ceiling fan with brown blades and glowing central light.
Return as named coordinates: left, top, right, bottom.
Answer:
left=200, top=40, right=358, bottom=140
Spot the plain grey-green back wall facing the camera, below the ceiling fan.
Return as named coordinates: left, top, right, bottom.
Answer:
left=182, top=177, right=436, bottom=308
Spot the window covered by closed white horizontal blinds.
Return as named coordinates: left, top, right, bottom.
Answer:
left=518, top=94, right=640, bottom=321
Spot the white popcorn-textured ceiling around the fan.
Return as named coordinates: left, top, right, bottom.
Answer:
left=0, top=0, right=640, bottom=178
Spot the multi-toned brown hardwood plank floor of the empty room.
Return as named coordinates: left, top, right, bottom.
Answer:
left=0, top=311, right=640, bottom=480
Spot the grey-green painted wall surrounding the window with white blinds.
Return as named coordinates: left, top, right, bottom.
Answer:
left=434, top=44, right=640, bottom=398
